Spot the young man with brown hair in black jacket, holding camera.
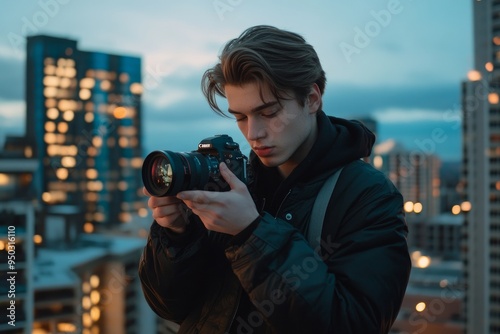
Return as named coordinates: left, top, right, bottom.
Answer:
left=139, top=26, right=411, bottom=334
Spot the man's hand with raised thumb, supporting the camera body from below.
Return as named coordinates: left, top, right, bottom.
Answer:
left=177, top=163, right=259, bottom=235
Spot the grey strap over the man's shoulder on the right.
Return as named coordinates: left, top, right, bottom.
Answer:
left=307, top=167, right=343, bottom=253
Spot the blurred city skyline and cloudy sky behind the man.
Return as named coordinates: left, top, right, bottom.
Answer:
left=0, top=0, right=492, bottom=334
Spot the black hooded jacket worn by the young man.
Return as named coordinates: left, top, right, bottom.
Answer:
left=139, top=112, right=411, bottom=334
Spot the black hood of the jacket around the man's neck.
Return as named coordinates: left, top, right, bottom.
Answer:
left=250, top=111, right=375, bottom=211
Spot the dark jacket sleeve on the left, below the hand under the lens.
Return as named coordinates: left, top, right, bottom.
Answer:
left=139, top=221, right=209, bottom=323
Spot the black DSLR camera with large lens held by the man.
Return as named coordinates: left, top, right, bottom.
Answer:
left=142, top=134, right=248, bottom=197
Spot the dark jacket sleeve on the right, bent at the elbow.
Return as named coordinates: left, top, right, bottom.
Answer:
left=226, top=165, right=411, bottom=334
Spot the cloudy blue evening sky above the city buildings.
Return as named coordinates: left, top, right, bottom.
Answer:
left=0, top=0, right=473, bottom=161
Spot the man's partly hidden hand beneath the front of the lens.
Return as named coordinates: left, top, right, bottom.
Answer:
left=142, top=188, right=193, bottom=233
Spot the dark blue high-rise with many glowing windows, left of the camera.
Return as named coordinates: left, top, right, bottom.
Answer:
left=26, top=36, right=143, bottom=229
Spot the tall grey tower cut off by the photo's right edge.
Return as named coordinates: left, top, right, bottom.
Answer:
left=462, top=0, right=500, bottom=334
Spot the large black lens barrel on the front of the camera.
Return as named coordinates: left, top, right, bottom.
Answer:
left=142, top=151, right=218, bottom=197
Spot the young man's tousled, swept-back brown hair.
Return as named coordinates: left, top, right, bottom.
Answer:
left=201, top=25, right=326, bottom=115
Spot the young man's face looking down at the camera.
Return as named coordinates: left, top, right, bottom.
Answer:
left=225, top=83, right=321, bottom=177
